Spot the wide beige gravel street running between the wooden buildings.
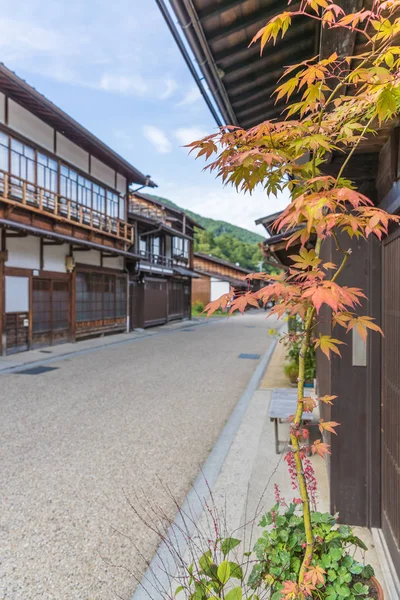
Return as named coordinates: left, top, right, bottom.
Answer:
left=0, top=311, right=275, bottom=600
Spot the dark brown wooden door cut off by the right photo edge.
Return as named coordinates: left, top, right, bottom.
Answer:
left=382, top=226, right=400, bottom=575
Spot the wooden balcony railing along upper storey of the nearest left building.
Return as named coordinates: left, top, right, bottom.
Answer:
left=0, top=170, right=134, bottom=244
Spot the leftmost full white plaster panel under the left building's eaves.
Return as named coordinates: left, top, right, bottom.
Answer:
left=8, top=99, right=54, bottom=152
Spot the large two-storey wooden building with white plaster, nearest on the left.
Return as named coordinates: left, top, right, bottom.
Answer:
left=0, top=65, right=155, bottom=354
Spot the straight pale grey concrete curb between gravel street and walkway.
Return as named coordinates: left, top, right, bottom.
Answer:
left=132, top=338, right=278, bottom=600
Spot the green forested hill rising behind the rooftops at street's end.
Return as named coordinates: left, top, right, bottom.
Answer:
left=146, top=194, right=276, bottom=271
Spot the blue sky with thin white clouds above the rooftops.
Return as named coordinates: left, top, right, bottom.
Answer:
left=0, top=0, right=285, bottom=233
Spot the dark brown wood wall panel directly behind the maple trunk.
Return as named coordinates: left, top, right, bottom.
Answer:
left=317, top=235, right=380, bottom=527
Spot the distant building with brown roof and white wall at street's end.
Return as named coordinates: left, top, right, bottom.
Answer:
left=192, top=252, right=251, bottom=305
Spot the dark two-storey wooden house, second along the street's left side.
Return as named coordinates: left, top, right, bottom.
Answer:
left=127, top=192, right=202, bottom=330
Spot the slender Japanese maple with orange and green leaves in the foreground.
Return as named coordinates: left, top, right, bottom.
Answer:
left=189, top=0, right=400, bottom=600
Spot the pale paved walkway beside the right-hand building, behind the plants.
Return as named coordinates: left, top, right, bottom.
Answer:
left=138, top=336, right=390, bottom=600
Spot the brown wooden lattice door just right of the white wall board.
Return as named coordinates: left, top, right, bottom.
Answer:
left=32, top=277, right=70, bottom=348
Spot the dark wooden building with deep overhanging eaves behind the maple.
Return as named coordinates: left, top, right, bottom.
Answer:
left=161, top=0, right=400, bottom=584
